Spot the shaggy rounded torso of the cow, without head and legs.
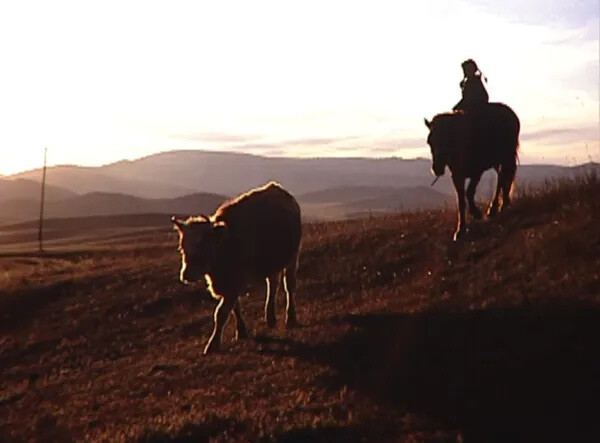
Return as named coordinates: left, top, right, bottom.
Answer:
left=213, top=182, right=302, bottom=277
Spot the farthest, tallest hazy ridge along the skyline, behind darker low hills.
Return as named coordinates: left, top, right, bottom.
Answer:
left=13, top=150, right=600, bottom=198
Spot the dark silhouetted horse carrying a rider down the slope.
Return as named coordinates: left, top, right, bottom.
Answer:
left=425, top=103, right=520, bottom=240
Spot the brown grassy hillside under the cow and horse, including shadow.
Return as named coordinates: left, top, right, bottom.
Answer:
left=0, top=176, right=600, bottom=442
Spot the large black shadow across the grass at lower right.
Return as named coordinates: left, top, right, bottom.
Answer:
left=265, top=305, right=600, bottom=441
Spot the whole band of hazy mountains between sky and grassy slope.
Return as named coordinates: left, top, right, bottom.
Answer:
left=0, top=151, right=600, bottom=224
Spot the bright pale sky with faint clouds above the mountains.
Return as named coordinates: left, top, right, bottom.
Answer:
left=0, top=0, right=600, bottom=174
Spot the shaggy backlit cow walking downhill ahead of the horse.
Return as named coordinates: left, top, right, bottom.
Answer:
left=171, top=182, right=302, bottom=354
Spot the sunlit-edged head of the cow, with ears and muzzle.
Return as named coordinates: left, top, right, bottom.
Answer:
left=171, top=215, right=227, bottom=283
